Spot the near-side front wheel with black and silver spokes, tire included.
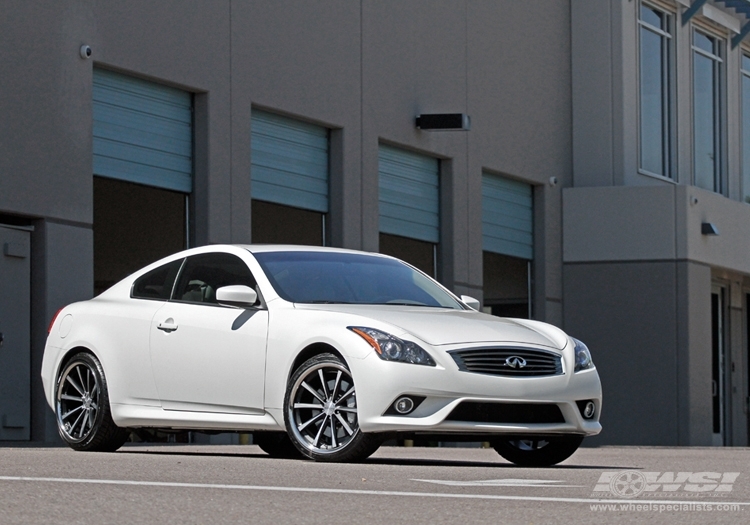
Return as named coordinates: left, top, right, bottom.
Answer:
left=284, top=354, right=380, bottom=462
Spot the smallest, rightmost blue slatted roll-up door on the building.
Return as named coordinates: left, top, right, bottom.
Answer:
left=482, top=173, right=534, bottom=260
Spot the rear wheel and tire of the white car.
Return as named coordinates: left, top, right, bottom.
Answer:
left=55, top=352, right=130, bottom=452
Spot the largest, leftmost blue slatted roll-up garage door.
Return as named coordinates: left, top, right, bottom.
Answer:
left=93, top=69, right=193, bottom=193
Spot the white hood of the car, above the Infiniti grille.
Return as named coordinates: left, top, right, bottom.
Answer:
left=296, top=304, right=568, bottom=350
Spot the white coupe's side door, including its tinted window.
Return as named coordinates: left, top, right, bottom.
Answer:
left=150, top=252, right=268, bottom=414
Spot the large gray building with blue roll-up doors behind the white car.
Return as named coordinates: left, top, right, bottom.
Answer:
left=0, top=0, right=750, bottom=446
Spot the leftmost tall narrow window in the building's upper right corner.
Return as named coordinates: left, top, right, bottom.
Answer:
left=638, top=4, right=673, bottom=178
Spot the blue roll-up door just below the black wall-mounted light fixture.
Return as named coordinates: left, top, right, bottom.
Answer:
left=378, top=145, right=440, bottom=243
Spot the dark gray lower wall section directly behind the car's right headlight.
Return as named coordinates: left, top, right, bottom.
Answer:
left=563, top=262, right=680, bottom=445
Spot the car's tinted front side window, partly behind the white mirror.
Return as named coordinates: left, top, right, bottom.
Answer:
left=173, top=253, right=255, bottom=304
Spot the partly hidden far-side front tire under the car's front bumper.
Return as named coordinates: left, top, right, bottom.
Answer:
left=492, top=436, right=583, bottom=467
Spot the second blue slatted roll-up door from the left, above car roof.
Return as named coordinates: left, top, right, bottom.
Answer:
left=251, top=110, right=329, bottom=213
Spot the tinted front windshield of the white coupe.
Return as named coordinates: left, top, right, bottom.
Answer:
left=253, top=252, right=463, bottom=310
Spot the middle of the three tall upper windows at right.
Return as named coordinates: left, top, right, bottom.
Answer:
left=693, top=29, right=723, bottom=193
